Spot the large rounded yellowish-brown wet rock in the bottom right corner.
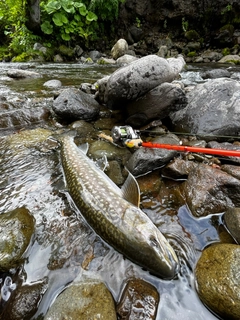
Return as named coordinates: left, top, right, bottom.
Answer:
left=195, top=244, right=240, bottom=320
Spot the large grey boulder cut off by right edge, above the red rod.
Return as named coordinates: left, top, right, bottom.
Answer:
left=170, top=78, right=240, bottom=135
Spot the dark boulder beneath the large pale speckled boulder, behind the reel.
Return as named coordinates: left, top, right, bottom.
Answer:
left=126, top=82, right=187, bottom=127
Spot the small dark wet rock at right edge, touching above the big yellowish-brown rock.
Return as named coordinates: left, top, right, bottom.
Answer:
left=224, top=208, right=240, bottom=244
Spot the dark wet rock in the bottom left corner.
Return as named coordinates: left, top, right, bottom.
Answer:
left=1, top=278, right=48, bottom=320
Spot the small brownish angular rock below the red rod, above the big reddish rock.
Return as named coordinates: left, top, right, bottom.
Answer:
left=162, top=158, right=198, bottom=179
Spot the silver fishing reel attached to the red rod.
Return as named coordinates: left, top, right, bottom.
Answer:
left=111, top=126, right=142, bottom=148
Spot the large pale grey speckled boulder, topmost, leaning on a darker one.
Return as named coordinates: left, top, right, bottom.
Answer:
left=100, top=55, right=183, bottom=109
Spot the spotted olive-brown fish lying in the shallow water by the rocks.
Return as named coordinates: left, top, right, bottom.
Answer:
left=57, top=134, right=179, bottom=279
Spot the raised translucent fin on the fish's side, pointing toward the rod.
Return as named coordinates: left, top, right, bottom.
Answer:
left=121, top=170, right=140, bottom=207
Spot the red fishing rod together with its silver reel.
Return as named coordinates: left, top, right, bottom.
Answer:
left=112, top=126, right=240, bottom=157
